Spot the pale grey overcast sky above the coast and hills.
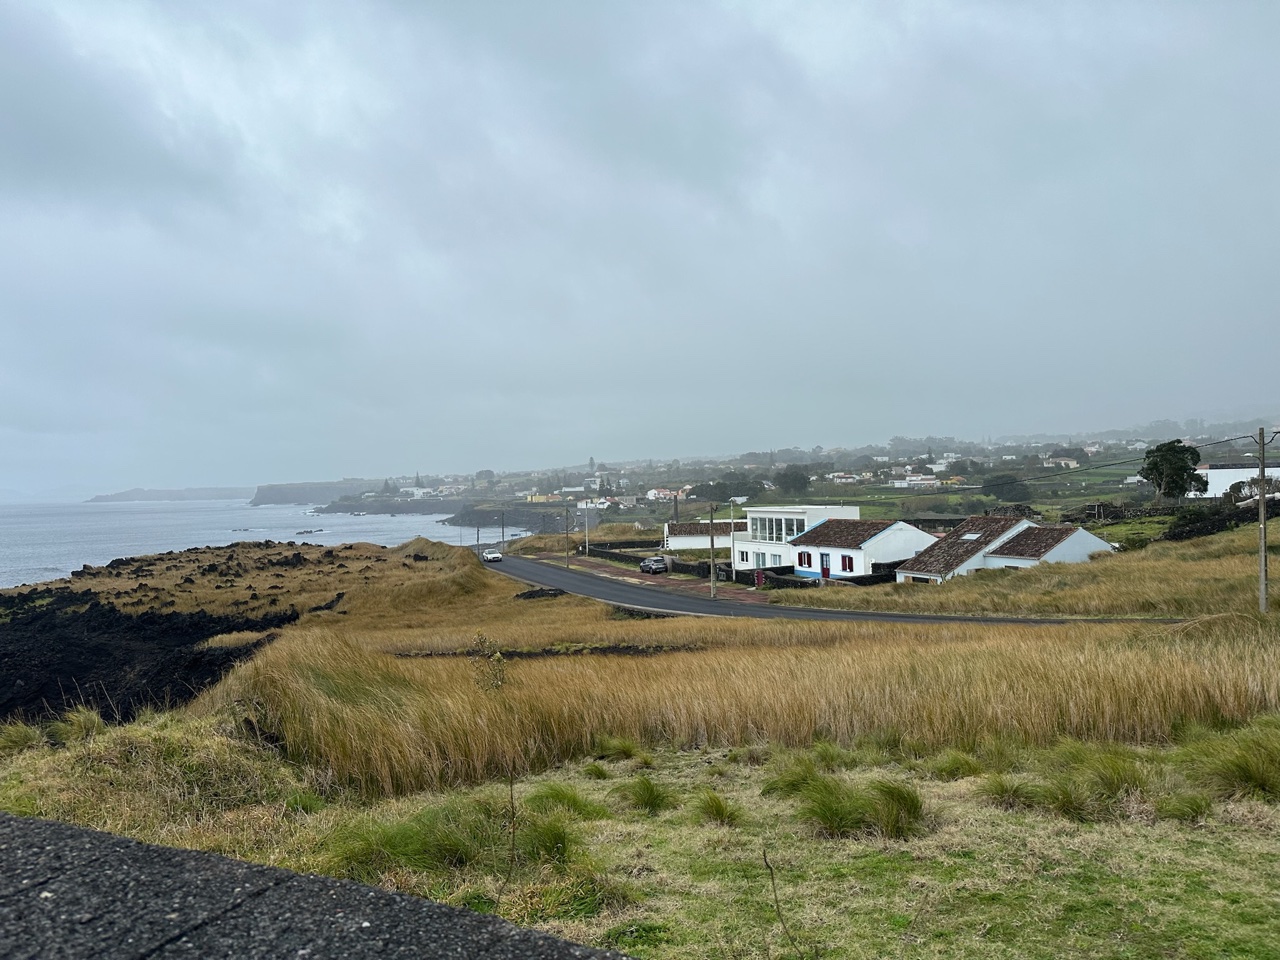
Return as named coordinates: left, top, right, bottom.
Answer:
left=0, top=0, right=1280, bottom=499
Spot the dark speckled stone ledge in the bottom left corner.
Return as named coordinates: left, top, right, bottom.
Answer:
left=0, top=813, right=622, bottom=960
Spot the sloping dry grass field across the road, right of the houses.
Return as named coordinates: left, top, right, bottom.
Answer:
left=776, top=521, right=1280, bottom=617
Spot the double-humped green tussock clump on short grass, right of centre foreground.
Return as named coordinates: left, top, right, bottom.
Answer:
left=799, top=776, right=925, bottom=840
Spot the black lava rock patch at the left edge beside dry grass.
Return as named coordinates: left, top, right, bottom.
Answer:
left=0, top=586, right=298, bottom=721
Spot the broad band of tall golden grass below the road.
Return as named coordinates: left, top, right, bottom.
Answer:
left=197, top=535, right=1280, bottom=795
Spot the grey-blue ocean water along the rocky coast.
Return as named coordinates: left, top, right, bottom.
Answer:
left=0, top=500, right=525, bottom=588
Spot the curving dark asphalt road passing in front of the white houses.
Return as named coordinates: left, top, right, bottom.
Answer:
left=489, top=556, right=1090, bottom=625
